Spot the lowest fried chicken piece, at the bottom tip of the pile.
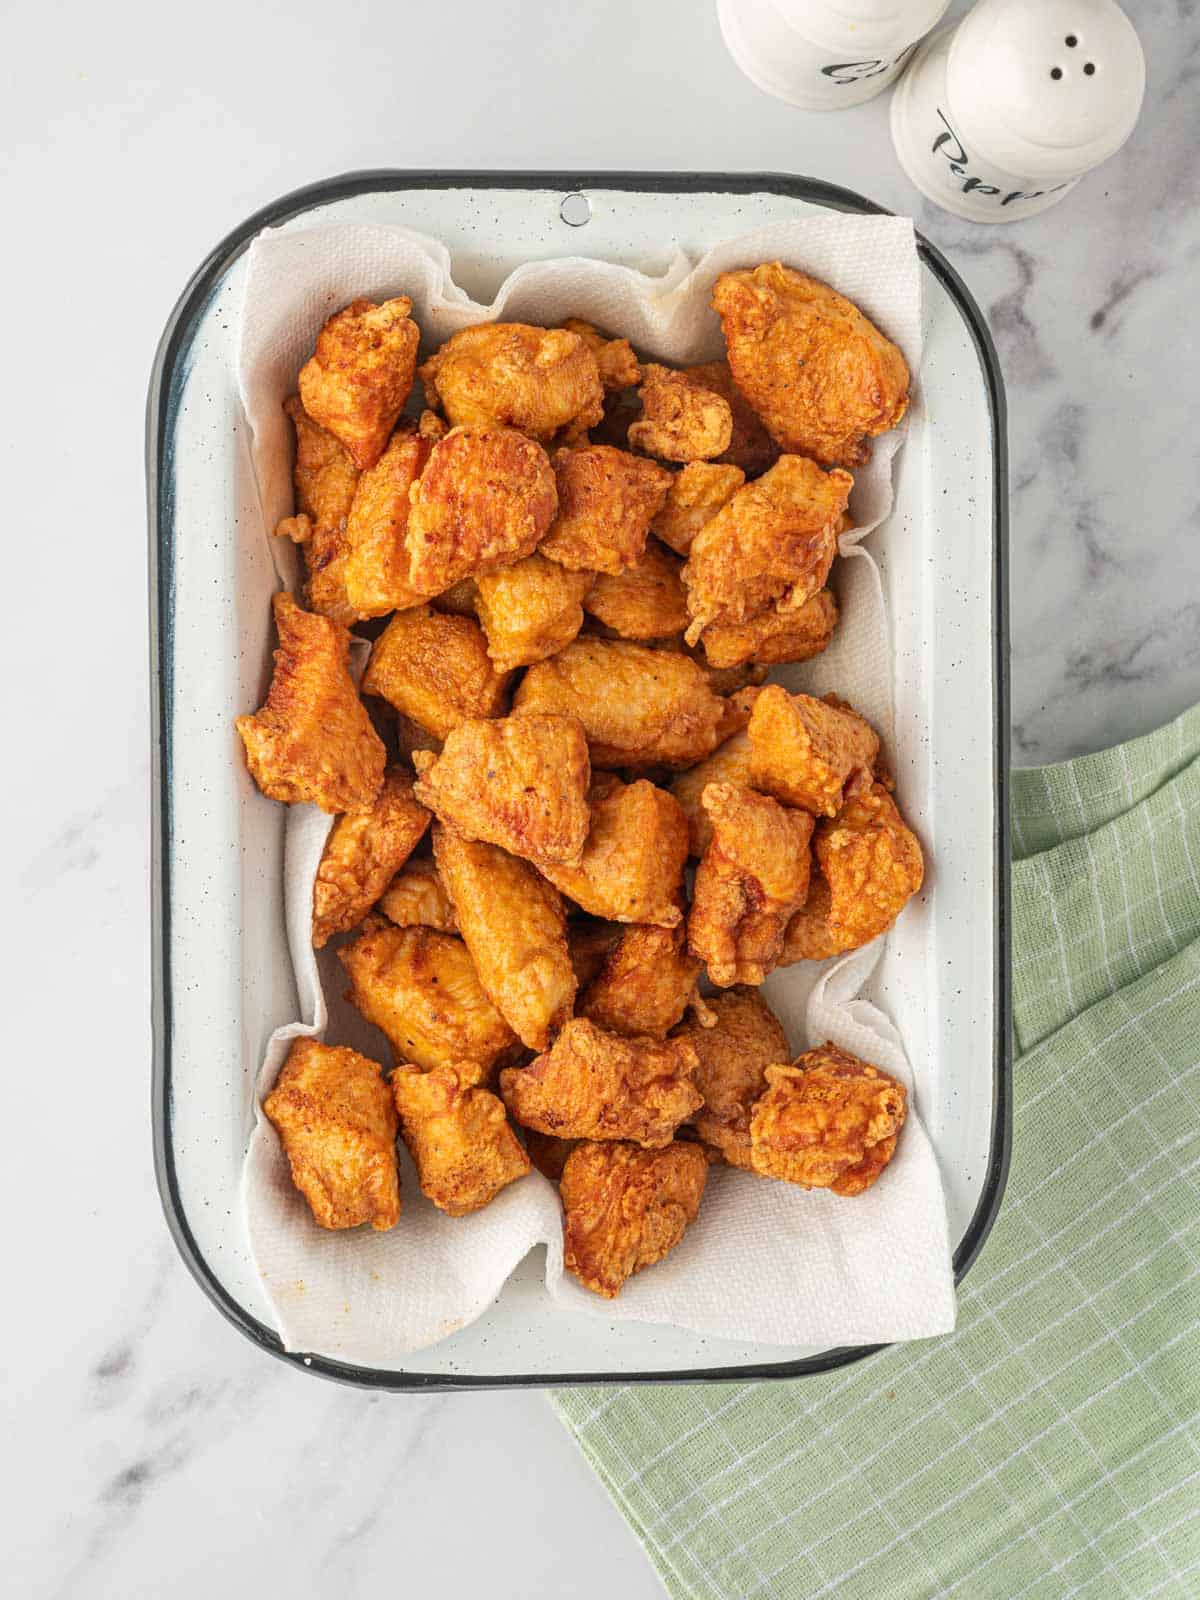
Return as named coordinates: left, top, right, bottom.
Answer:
left=558, top=1142, right=709, bottom=1299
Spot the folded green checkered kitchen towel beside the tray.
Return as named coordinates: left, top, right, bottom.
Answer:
left=555, top=707, right=1200, bottom=1600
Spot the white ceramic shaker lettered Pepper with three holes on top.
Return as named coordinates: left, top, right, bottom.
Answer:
left=891, top=0, right=1146, bottom=222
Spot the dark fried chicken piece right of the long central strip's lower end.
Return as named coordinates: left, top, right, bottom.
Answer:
left=578, top=923, right=707, bottom=1038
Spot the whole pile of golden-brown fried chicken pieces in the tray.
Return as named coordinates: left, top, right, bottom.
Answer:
left=237, top=262, right=923, bottom=1296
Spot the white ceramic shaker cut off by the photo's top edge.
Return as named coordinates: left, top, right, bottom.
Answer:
left=717, top=0, right=950, bottom=110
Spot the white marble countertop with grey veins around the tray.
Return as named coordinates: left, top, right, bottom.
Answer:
left=0, top=0, right=1200, bottom=1600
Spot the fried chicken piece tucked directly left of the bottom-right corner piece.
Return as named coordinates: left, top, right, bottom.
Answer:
left=672, top=987, right=790, bottom=1171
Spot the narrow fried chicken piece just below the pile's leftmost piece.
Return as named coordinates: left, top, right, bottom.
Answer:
left=312, top=766, right=429, bottom=950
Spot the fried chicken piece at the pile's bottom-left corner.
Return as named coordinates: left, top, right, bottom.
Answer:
left=262, top=1038, right=400, bottom=1232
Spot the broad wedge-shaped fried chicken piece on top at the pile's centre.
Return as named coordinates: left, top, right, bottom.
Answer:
left=413, top=710, right=592, bottom=866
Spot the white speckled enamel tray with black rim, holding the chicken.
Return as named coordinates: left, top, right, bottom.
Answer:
left=147, top=171, right=1011, bottom=1389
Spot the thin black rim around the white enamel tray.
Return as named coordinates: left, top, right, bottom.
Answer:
left=146, top=168, right=1013, bottom=1392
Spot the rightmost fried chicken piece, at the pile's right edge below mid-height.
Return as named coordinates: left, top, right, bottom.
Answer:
left=781, top=782, right=925, bottom=965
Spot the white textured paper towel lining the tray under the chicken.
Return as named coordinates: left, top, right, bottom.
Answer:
left=238, top=216, right=955, bottom=1366
